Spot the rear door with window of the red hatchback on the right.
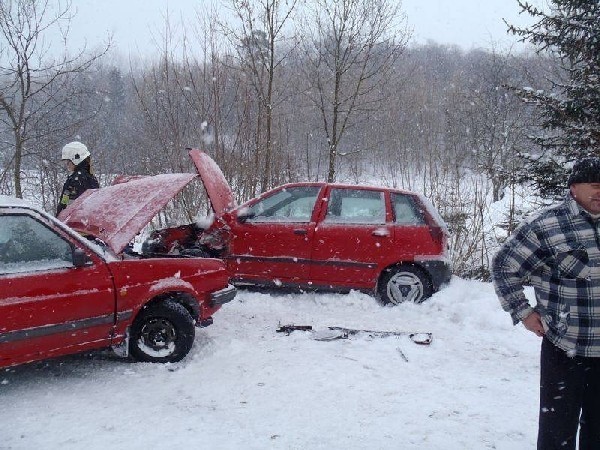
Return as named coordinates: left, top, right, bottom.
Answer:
left=310, top=187, right=393, bottom=289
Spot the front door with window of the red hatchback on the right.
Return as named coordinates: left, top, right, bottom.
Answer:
left=227, top=185, right=321, bottom=285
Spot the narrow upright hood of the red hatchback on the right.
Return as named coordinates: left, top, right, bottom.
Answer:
left=190, top=149, right=237, bottom=217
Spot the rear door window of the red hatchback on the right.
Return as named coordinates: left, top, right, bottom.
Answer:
left=325, top=188, right=385, bottom=224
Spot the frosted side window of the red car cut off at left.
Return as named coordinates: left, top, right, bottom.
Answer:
left=0, top=215, right=73, bottom=274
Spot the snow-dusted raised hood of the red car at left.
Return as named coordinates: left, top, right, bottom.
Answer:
left=58, top=173, right=198, bottom=253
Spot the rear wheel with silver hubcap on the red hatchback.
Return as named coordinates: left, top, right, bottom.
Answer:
left=378, top=264, right=433, bottom=305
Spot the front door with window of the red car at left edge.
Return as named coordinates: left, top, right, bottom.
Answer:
left=0, top=210, right=115, bottom=365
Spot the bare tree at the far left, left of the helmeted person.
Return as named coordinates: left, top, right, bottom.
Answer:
left=0, top=0, right=110, bottom=197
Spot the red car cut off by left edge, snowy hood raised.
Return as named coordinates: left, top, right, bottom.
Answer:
left=0, top=174, right=235, bottom=367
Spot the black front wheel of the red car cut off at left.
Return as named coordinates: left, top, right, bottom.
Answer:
left=129, top=300, right=195, bottom=363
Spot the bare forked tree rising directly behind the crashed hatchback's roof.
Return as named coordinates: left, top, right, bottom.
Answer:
left=303, top=0, right=409, bottom=181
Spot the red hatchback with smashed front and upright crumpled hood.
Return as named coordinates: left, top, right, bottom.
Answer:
left=143, top=150, right=451, bottom=304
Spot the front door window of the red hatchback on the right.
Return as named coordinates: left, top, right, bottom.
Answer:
left=248, top=186, right=320, bottom=223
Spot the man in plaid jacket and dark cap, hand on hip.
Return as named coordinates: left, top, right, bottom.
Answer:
left=492, top=157, right=600, bottom=450
